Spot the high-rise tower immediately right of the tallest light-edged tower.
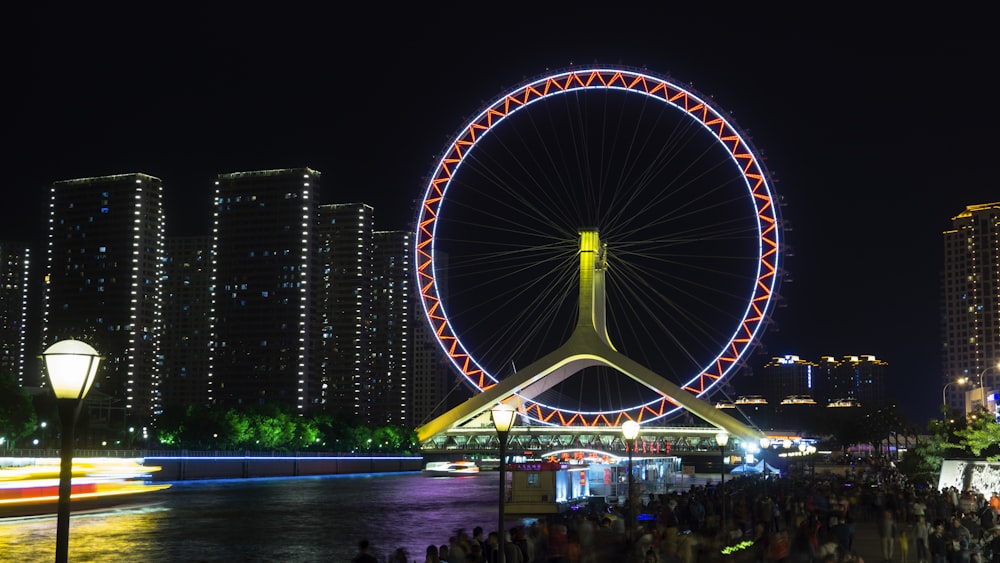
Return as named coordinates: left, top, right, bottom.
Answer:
left=317, top=203, right=374, bottom=420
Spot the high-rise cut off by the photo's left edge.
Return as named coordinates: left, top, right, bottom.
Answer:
left=0, top=241, right=33, bottom=387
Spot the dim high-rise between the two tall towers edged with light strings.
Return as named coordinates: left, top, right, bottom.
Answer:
left=160, top=235, right=212, bottom=410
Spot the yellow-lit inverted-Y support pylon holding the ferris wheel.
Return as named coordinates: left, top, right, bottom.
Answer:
left=417, top=229, right=764, bottom=443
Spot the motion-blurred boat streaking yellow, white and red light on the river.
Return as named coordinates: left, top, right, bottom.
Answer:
left=0, top=458, right=170, bottom=518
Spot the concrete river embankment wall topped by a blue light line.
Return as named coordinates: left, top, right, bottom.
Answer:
left=143, top=456, right=423, bottom=481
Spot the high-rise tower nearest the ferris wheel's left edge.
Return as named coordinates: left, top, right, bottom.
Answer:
left=365, top=231, right=414, bottom=426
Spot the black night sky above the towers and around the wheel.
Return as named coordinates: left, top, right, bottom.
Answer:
left=0, top=3, right=1000, bottom=428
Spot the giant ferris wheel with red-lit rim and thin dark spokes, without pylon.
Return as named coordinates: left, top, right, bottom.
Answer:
left=414, top=67, right=781, bottom=425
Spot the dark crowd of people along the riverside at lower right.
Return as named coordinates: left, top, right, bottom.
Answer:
left=355, top=460, right=1000, bottom=563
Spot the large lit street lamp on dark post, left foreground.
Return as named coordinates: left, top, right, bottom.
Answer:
left=42, top=340, right=101, bottom=563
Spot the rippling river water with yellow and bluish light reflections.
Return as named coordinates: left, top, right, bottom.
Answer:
left=0, top=472, right=512, bottom=562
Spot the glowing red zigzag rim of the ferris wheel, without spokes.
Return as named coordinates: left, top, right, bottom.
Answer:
left=414, top=67, right=780, bottom=422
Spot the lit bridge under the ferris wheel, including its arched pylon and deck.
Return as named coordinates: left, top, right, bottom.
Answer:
left=417, top=229, right=766, bottom=453
